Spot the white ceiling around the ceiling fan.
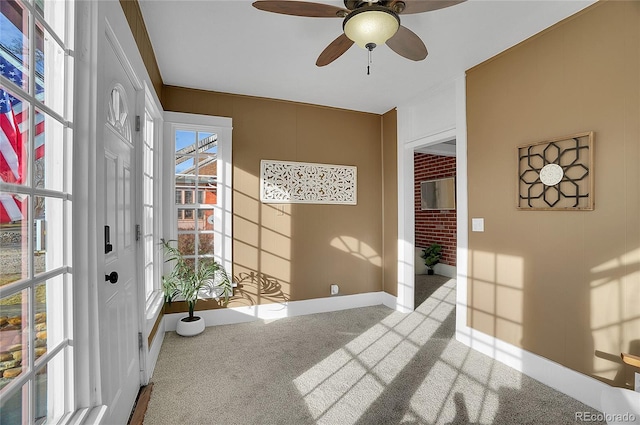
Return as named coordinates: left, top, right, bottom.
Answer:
left=139, top=0, right=594, bottom=114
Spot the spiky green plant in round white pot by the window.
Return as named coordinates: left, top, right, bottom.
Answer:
left=162, top=239, right=233, bottom=336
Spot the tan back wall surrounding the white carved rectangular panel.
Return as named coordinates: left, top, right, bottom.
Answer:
left=163, top=86, right=383, bottom=306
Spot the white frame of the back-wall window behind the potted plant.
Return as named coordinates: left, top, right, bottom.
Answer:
left=163, top=112, right=233, bottom=280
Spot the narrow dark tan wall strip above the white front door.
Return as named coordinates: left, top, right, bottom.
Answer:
left=120, top=0, right=162, bottom=101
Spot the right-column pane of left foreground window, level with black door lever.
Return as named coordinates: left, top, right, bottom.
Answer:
left=33, top=196, right=64, bottom=275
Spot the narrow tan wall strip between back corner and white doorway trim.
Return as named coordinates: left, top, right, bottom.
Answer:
left=382, top=109, right=398, bottom=297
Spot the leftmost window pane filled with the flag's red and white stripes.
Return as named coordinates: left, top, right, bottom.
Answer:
left=0, top=86, right=29, bottom=185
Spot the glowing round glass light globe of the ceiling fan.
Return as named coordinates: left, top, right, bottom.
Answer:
left=344, top=9, right=400, bottom=49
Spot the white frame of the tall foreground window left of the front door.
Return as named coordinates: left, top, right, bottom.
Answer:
left=0, top=0, right=77, bottom=423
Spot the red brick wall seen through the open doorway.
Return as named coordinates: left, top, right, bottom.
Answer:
left=414, top=152, right=456, bottom=266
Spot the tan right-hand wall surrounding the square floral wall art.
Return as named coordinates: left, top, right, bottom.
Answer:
left=467, top=1, right=640, bottom=386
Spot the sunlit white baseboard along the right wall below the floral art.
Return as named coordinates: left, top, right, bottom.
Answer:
left=456, top=326, right=609, bottom=410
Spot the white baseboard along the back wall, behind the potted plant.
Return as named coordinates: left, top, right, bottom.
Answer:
left=164, top=292, right=396, bottom=332
